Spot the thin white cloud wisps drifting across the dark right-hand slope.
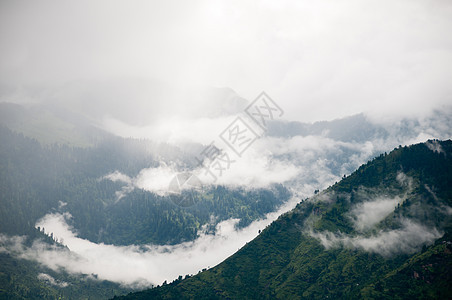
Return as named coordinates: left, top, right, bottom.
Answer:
left=305, top=172, right=448, bottom=256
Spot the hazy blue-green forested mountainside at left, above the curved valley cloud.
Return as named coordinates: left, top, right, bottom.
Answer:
left=0, top=126, right=290, bottom=245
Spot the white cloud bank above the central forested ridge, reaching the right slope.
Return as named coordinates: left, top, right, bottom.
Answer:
left=100, top=121, right=442, bottom=198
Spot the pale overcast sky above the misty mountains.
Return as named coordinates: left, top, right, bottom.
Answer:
left=0, top=0, right=452, bottom=121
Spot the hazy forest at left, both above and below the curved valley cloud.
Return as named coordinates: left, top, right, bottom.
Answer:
left=0, top=125, right=290, bottom=299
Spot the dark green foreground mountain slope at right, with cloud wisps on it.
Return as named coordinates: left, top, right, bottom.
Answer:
left=115, top=140, right=452, bottom=299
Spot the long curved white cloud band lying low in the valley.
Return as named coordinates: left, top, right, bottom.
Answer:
left=0, top=198, right=300, bottom=288
